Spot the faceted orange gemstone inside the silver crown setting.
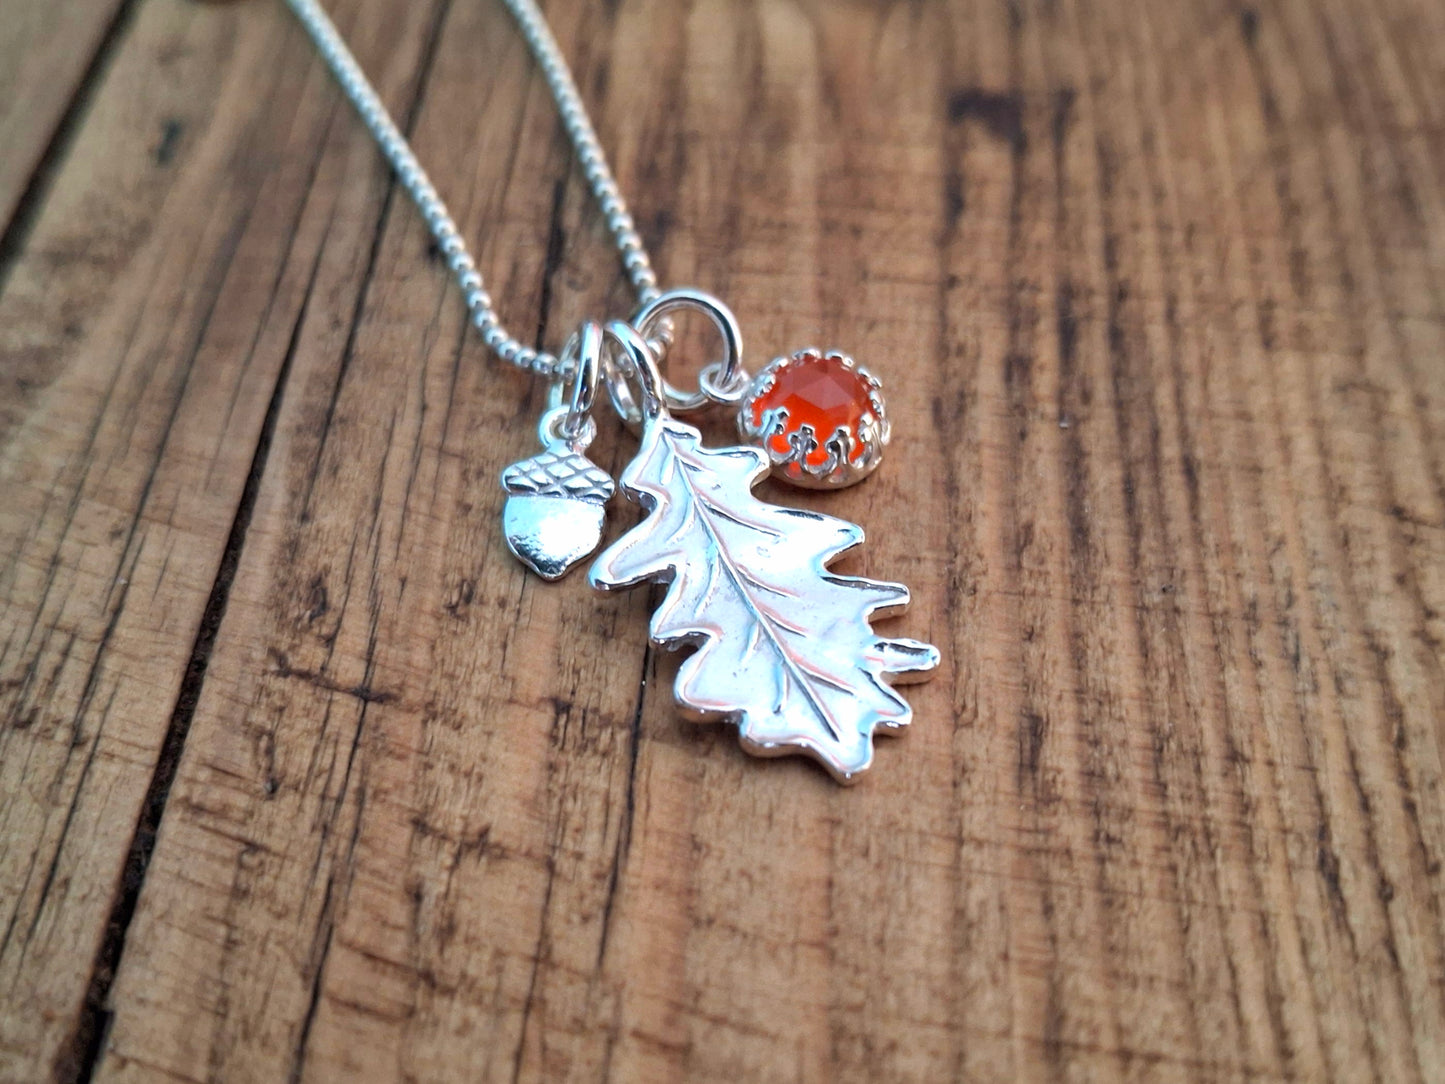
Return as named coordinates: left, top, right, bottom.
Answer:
left=751, top=354, right=873, bottom=467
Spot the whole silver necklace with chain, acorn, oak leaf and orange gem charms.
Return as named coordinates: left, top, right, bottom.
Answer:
left=286, top=0, right=939, bottom=783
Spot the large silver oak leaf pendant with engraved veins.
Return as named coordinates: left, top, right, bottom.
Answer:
left=591, top=410, right=939, bottom=783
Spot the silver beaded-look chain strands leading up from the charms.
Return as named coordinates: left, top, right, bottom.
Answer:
left=286, top=0, right=659, bottom=377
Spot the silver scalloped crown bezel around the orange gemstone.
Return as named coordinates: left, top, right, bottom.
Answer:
left=737, top=347, right=890, bottom=490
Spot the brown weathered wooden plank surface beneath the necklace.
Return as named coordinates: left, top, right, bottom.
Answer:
left=0, top=0, right=1445, bottom=1081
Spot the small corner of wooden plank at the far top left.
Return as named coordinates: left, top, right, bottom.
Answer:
left=0, top=0, right=134, bottom=241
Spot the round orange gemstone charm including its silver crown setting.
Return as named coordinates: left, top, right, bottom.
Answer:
left=737, top=347, right=889, bottom=490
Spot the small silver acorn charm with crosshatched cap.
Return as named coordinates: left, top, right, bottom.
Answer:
left=501, top=427, right=614, bottom=580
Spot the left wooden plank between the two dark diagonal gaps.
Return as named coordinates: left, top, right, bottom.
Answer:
left=0, top=0, right=450, bottom=1080
